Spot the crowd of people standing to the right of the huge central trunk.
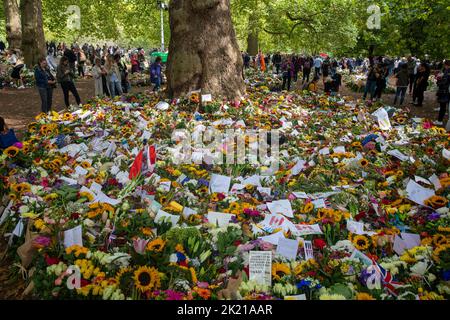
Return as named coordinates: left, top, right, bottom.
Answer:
left=242, top=51, right=450, bottom=125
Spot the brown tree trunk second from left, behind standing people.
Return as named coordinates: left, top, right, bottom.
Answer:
left=20, top=0, right=46, bottom=67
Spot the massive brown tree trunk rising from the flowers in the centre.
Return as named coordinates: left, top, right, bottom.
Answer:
left=167, top=0, right=245, bottom=99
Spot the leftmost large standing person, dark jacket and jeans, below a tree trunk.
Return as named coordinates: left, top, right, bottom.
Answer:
left=34, top=58, right=56, bottom=113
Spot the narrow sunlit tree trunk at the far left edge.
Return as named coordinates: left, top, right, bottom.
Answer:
left=3, top=0, right=22, bottom=50
